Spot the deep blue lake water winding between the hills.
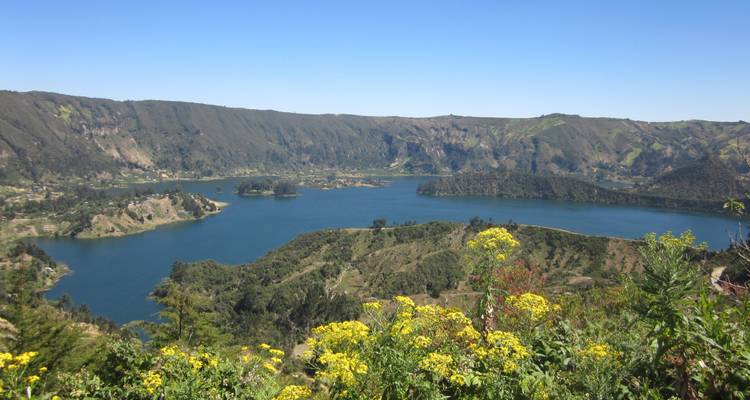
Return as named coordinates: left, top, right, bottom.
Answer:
left=37, top=177, right=737, bottom=323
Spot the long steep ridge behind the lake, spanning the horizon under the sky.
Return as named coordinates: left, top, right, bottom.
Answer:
left=0, top=91, right=750, bottom=180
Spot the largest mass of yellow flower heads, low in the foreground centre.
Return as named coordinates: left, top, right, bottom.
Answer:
left=306, top=296, right=549, bottom=393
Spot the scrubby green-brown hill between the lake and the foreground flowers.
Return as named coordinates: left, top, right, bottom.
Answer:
left=155, top=220, right=639, bottom=343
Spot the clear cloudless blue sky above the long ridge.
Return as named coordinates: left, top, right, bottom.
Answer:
left=0, top=0, right=750, bottom=121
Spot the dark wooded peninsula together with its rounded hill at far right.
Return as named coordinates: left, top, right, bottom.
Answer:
left=417, top=162, right=743, bottom=212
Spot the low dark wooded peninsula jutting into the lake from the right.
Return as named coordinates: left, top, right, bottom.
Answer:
left=417, top=170, right=734, bottom=212
